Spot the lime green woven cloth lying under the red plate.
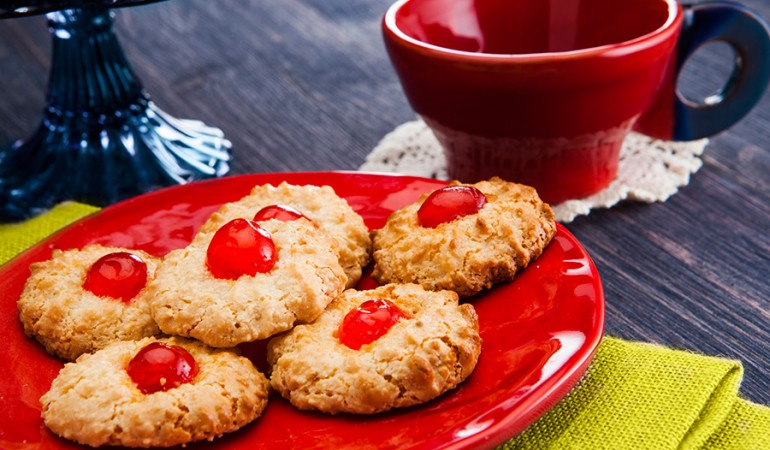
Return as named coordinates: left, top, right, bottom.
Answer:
left=0, top=203, right=770, bottom=450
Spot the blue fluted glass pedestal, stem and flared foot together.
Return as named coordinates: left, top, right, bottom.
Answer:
left=0, top=8, right=231, bottom=221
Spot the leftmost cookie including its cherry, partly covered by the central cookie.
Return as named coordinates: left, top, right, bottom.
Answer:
left=17, top=245, right=160, bottom=361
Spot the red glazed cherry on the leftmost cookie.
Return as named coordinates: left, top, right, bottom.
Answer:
left=83, top=252, right=147, bottom=303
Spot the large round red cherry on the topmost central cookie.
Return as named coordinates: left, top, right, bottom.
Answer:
left=206, top=219, right=278, bottom=280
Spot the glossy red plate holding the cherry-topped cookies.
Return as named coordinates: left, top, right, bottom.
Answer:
left=0, top=172, right=604, bottom=450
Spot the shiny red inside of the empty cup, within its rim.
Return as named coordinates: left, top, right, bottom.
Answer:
left=392, top=0, right=674, bottom=55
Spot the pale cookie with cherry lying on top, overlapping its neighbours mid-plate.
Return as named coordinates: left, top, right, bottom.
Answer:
left=150, top=218, right=346, bottom=347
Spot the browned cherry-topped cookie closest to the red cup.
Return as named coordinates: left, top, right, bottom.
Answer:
left=372, top=177, right=556, bottom=297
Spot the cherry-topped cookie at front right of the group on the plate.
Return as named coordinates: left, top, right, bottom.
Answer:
left=268, top=284, right=481, bottom=414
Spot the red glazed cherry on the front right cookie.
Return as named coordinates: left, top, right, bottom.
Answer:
left=337, top=298, right=407, bottom=350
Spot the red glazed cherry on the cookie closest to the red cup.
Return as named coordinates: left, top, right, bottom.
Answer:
left=417, top=186, right=487, bottom=228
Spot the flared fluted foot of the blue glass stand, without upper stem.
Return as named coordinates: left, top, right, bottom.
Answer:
left=0, top=97, right=231, bottom=220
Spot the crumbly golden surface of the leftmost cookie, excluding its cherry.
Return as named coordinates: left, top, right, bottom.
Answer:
left=17, top=245, right=160, bottom=361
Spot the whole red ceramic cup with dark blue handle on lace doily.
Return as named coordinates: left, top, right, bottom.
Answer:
left=382, top=0, right=770, bottom=203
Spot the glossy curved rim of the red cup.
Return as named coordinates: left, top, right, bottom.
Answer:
left=382, top=0, right=683, bottom=63
